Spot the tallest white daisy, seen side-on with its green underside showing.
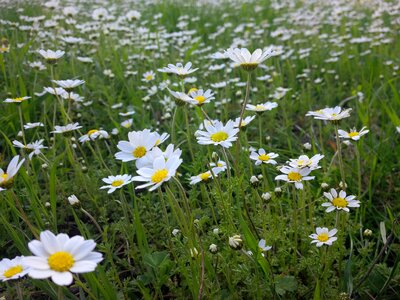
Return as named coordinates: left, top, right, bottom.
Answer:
left=224, top=47, right=276, bottom=71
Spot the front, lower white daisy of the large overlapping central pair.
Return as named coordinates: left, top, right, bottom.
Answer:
left=132, top=155, right=182, bottom=191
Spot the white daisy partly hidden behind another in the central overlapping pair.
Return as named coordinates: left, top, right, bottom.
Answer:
left=115, top=129, right=159, bottom=162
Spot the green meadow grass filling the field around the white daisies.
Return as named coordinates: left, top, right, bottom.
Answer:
left=0, top=1, right=400, bottom=299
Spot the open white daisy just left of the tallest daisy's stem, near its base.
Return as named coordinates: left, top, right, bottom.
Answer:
left=195, top=120, right=239, bottom=148
